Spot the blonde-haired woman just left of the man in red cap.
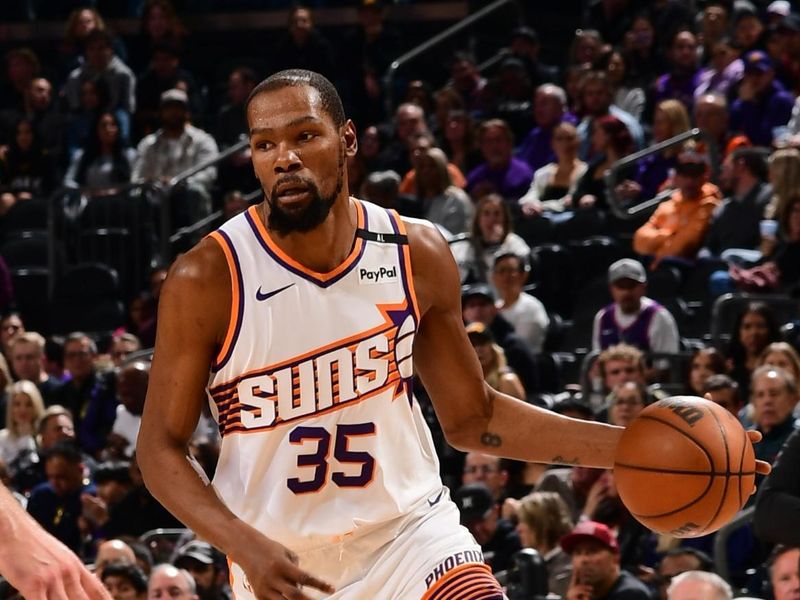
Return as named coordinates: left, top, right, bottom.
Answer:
left=517, top=492, right=573, bottom=598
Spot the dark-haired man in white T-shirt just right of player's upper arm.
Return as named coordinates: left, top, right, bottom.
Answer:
left=492, top=252, right=550, bottom=354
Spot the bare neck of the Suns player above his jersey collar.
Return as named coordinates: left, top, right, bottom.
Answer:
left=259, top=196, right=358, bottom=273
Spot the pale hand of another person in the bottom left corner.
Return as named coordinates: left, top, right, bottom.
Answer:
left=0, top=521, right=111, bottom=600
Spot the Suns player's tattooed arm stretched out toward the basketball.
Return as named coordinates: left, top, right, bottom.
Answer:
left=408, top=223, right=622, bottom=468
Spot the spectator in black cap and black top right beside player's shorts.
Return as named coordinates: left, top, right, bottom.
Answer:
left=453, top=483, right=522, bottom=573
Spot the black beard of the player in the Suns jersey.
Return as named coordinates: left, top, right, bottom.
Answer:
left=264, top=147, right=344, bottom=236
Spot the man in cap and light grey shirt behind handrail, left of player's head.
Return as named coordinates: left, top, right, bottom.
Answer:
left=132, top=88, right=219, bottom=233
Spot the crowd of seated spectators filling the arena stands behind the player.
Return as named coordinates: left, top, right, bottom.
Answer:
left=0, top=0, right=800, bottom=600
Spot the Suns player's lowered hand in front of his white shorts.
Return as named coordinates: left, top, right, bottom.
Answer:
left=234, top=536, right=335, bottom=600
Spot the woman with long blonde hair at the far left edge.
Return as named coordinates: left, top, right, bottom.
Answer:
left=0, top=381, right=44, bottom=464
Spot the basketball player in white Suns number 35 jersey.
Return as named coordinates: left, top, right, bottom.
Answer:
left=138, top=71, right=776, bottom=600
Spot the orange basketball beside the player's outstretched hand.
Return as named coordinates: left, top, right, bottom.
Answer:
left=614, top=396, right=756, bottom=537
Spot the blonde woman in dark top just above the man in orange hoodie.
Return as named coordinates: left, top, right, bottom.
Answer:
left=616, top=100, right=692, bottom=201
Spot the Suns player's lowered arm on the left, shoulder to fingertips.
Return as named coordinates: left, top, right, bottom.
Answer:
left=136, top=239, right=332, bottom=600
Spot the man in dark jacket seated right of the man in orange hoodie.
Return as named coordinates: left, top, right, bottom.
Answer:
left=700, top=148, right=773, bottom=264
